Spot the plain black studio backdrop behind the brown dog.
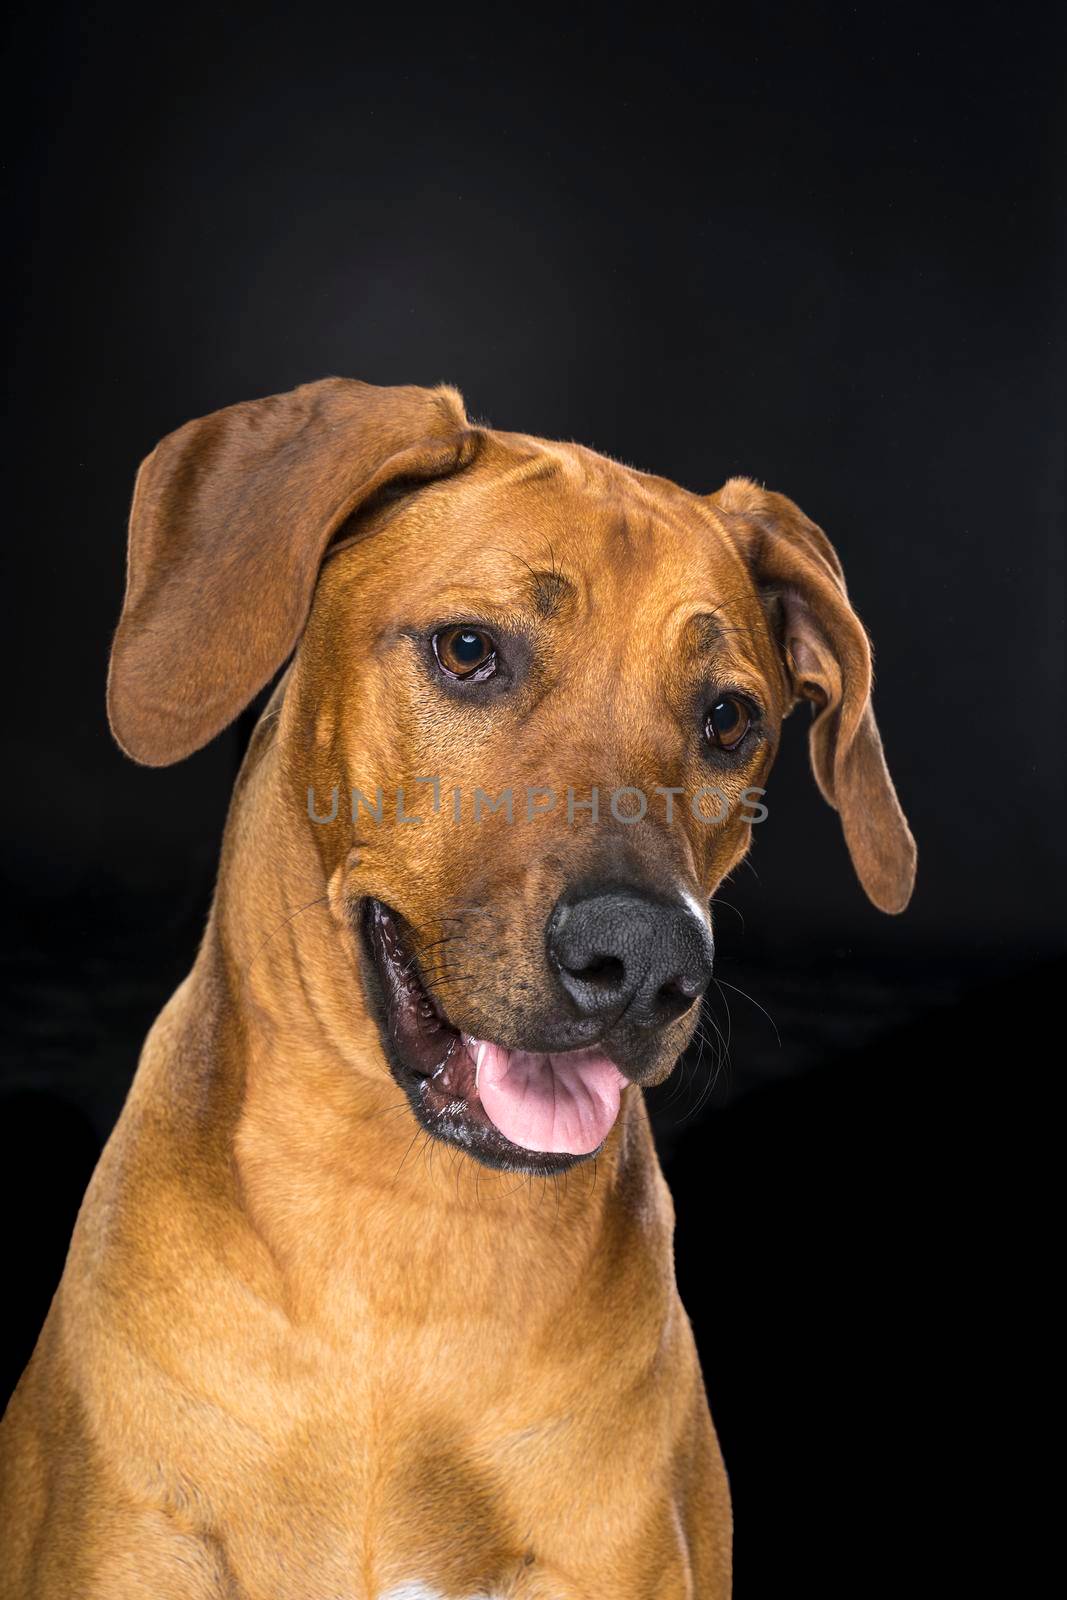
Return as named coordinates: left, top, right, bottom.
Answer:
left=2, top=5, right=1067, bottom=1600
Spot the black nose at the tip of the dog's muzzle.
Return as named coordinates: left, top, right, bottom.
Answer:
left=547, top=890, right=715, bottom=1027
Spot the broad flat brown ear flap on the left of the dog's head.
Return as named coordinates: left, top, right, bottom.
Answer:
left=107, top=378, right=477, bottom=766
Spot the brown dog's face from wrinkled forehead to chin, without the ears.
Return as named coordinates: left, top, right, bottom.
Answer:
left=288, top=438, right=787, bottom=1166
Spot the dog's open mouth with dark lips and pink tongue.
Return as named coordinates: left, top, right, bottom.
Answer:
left=363, top=899, right=629, bottom=1173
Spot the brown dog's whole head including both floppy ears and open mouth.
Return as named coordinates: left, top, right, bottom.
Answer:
left=109, top=379, right=915, bottom=1171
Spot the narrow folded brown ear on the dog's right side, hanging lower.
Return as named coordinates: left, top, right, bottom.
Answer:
left=709, top=478, right=915, bottom=912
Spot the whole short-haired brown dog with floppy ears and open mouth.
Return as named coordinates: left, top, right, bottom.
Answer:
left=0, top=379, right=915, bottom=1600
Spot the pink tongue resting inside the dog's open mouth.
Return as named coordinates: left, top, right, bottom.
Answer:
left=464, top=1038, right=627, bottom=1155
